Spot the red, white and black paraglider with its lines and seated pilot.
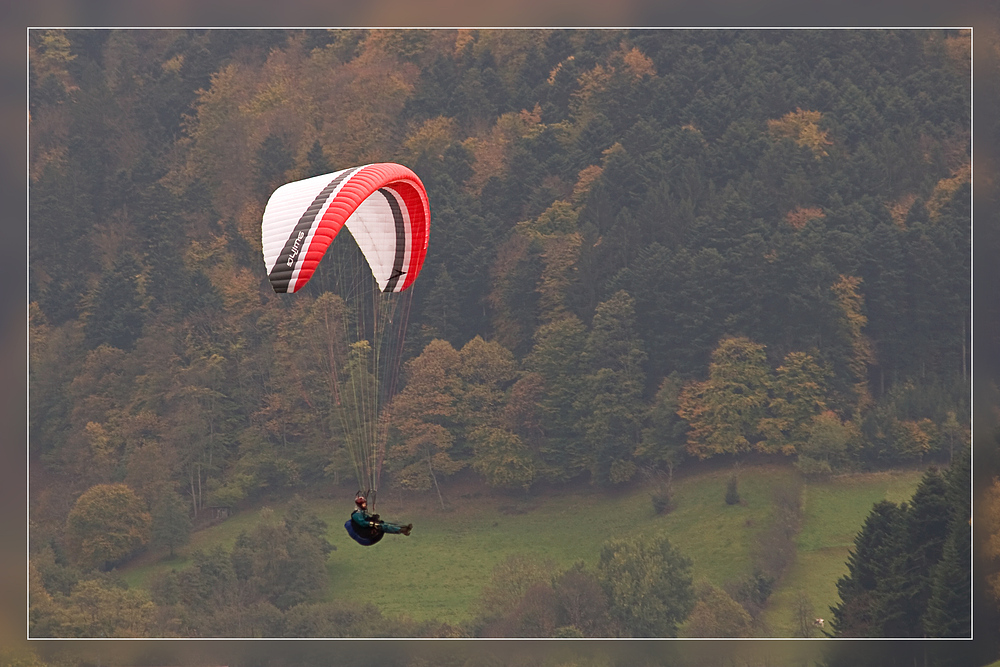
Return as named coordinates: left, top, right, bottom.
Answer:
left=261, top=163, right=430, bottom=546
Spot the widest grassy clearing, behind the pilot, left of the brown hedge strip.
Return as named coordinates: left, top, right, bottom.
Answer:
left=320, top=468, right=790, bottom=623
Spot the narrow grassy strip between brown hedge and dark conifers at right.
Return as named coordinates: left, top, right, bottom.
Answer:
left=764, top=470, right=923, bottom=637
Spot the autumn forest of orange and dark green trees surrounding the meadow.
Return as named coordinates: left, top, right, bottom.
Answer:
left=28, top=30, right=972, bottom=637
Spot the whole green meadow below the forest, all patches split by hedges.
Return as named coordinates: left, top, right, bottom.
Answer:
left=122, top=465, right=921, bottom=637
